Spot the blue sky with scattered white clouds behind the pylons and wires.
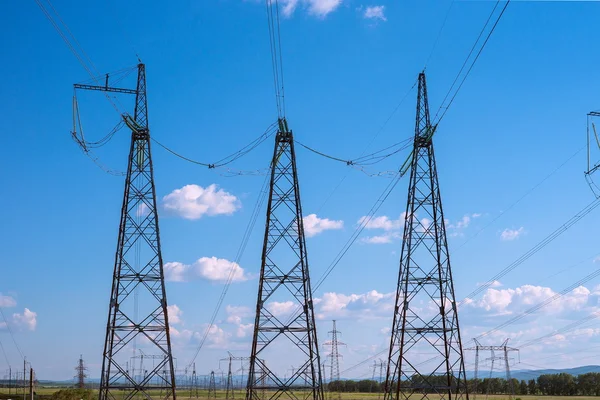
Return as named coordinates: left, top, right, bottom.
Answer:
left=0, top=0, right=600, bottom=379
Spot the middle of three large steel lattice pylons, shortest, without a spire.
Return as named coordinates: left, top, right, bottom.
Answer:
left=246, top=118, right=323, bottom=400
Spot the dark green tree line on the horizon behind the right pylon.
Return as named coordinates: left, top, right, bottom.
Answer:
left=325, top=372, right=600, bottom=396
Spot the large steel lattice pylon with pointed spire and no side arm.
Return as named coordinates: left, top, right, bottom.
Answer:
left=385, top=73, right=468, bottom=400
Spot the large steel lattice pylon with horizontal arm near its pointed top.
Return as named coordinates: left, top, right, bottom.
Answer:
left=86, top=64, right=175, bottom=400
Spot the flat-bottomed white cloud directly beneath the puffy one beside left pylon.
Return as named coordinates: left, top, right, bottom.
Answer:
left=164, top=257, right=249, bottom=282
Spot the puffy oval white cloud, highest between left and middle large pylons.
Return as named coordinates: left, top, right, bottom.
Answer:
left=163, top=184, right=241, bottom=220
